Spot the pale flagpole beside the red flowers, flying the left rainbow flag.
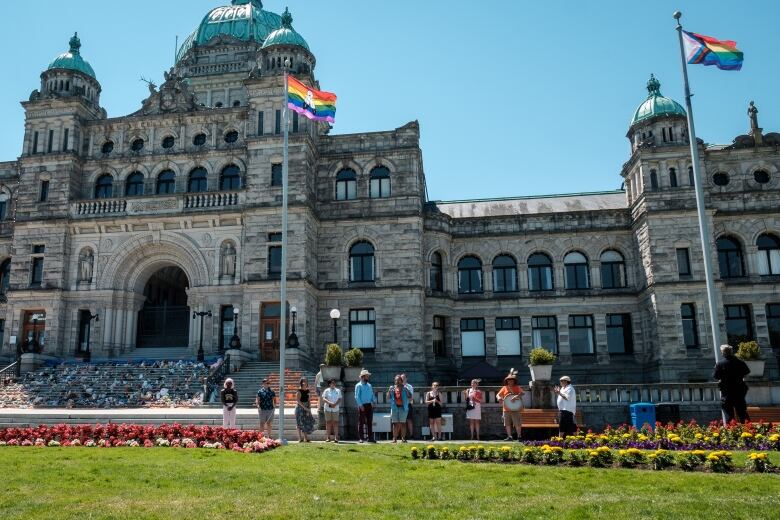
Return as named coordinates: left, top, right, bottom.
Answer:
left=279, top=58, right=290, bottom=443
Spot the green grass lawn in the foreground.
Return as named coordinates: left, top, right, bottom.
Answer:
left=0, top=444, right=780, bottom=520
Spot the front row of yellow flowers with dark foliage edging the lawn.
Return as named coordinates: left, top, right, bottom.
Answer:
left=411, top=444, right=778, bottom=473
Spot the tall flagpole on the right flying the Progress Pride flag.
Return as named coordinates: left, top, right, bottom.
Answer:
left=674, top=11, right=725, bottom=422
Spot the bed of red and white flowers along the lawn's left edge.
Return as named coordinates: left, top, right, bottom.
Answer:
left=0, top=424, right=281, bottom=453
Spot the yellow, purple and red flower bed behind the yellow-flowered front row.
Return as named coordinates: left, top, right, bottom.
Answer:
left=530, top=421, right=780, bottom=451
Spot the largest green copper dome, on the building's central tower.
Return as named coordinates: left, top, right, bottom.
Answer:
left=176, top=0, right=282, bottom=61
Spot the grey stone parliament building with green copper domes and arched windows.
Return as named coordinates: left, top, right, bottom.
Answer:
left=0, top=0, right=780, bottom=382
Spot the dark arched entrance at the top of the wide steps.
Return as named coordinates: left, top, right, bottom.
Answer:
left=136, top=266, right=190, bottom=348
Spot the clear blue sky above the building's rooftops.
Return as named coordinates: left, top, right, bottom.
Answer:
left=0, top=0, right=780, bottom=200
